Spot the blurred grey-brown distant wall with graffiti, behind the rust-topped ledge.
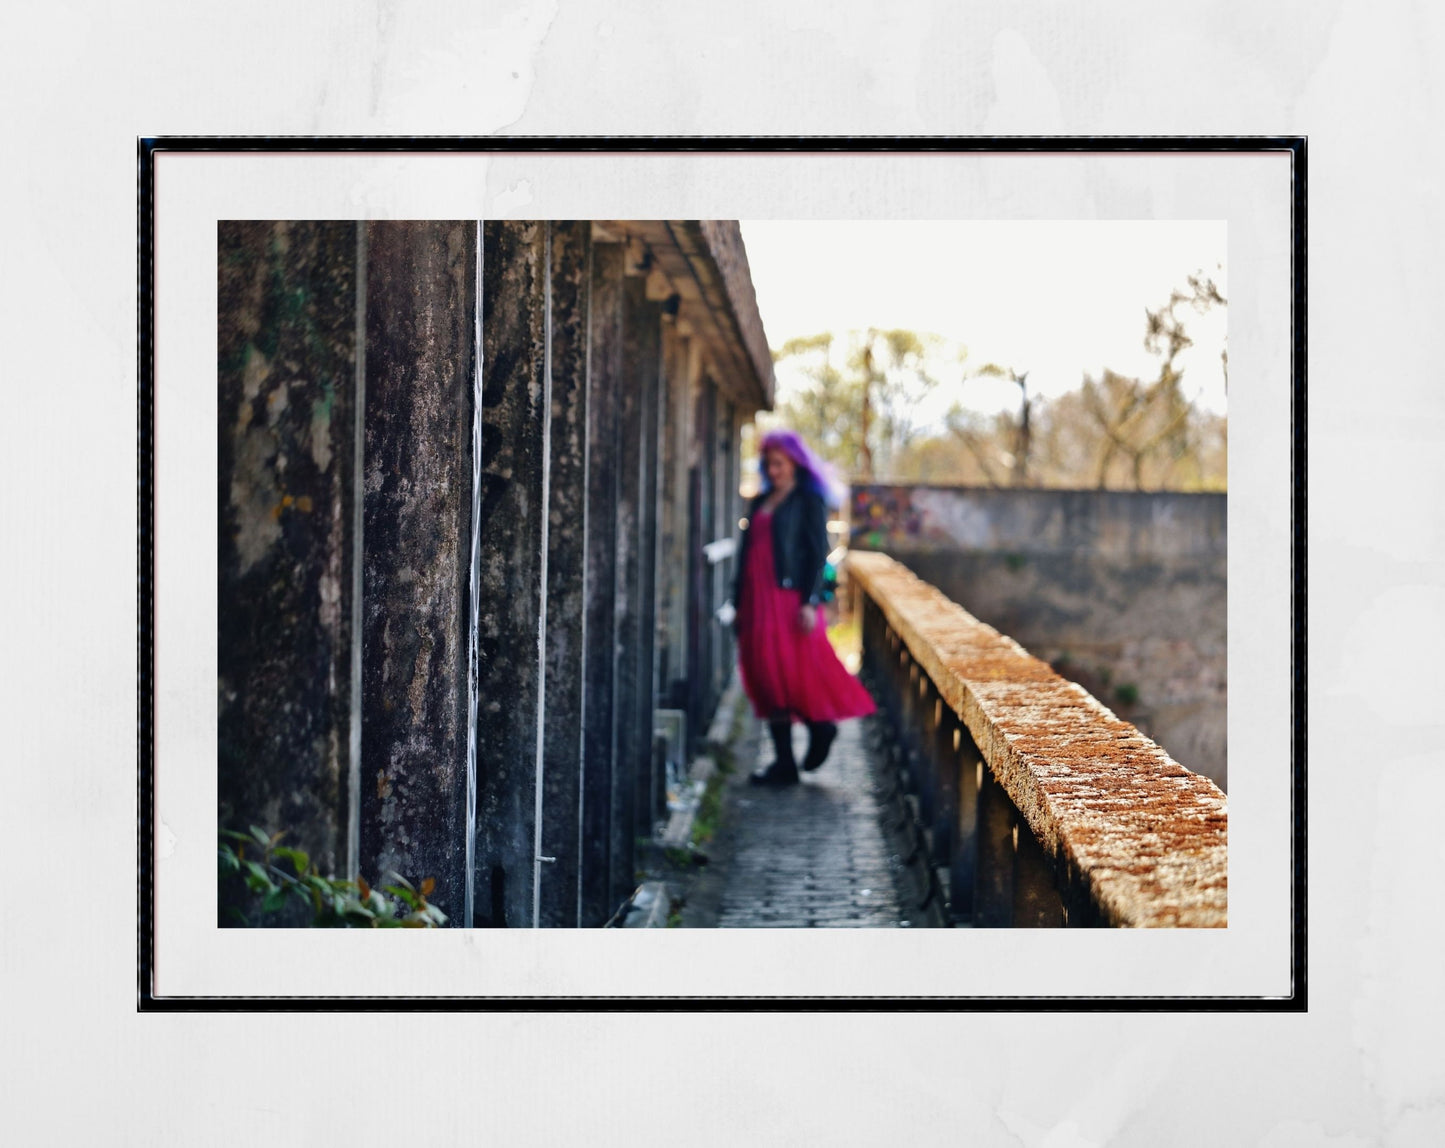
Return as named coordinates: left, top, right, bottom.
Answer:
left=851, top=484, right=1227, bottom=787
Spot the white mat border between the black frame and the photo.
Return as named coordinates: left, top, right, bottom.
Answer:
left=155, top=143, right=1292, bottom=1001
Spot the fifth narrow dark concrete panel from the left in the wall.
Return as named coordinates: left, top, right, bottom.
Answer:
left=581, top=243, right=631, bottom=927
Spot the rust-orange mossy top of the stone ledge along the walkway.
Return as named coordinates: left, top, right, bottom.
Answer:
left=848, top=551, right=1228, bottom=928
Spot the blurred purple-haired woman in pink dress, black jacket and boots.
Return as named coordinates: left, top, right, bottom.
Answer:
left=733, top=431, right=873, bottom=787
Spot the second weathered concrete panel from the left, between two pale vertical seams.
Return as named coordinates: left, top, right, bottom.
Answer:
left=358, top=223, right=477, bottom=918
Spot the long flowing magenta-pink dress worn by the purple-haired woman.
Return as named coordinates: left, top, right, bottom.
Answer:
left=737, top=513, right=874, bottom=721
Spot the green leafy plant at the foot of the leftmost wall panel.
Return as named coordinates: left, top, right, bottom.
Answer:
left=218, top=826, right=447, bottom=928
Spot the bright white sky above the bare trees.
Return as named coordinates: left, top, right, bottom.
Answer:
left=741, top=220, right=1230, bottom=424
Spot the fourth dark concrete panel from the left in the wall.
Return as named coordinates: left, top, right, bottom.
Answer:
left=538, top=221, right=592, bottom=927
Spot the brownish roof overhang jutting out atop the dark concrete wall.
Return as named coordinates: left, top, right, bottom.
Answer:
left=592, top=220, right=773, bottom=418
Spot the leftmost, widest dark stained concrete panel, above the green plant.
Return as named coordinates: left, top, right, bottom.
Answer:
left=217, top=223, right=357, bottom=872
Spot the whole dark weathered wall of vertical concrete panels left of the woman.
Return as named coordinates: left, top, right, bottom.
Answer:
left=220, top=221, right=772, bottom=927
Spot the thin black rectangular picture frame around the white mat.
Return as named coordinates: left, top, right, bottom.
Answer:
left=136, top=136, right=1308, bottom=1012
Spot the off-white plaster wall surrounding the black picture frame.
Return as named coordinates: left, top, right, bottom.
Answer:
left=0, top=0, right=1445, bottom=1147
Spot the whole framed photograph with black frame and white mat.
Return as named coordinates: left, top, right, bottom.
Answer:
left=137, top=137, right=1308, bottom=1011
